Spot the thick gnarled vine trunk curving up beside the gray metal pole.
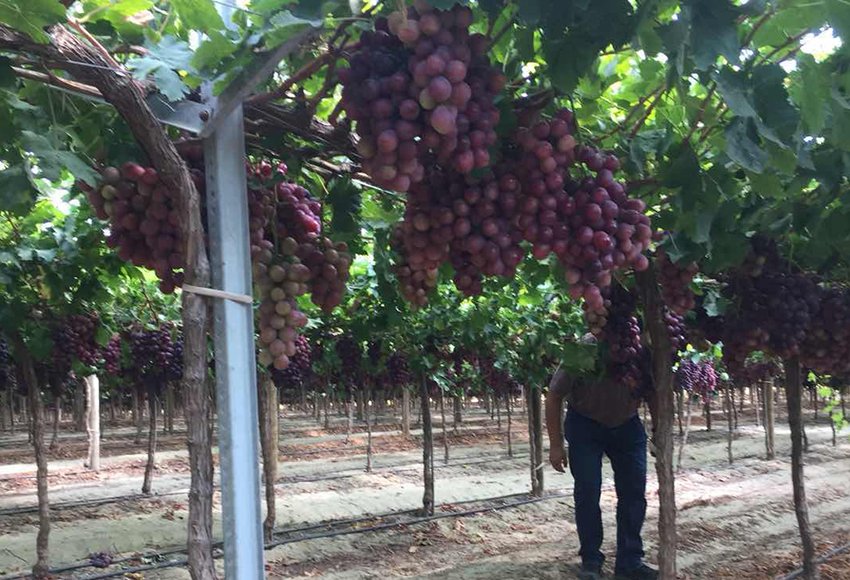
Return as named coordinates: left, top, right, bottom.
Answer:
left=0, top=25, right=215, bottom=580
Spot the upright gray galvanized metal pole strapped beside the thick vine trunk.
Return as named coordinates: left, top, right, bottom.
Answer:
left=204, top=105, right=264, bottom=580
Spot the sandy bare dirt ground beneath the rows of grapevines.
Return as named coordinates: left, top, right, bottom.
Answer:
left=0, top=402, right=850, bottom=580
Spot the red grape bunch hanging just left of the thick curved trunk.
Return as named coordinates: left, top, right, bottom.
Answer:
left=84, top=162, right=188, bottom=293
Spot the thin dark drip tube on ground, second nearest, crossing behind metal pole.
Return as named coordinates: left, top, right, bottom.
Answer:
left=0, top=453, right=528, bottom=516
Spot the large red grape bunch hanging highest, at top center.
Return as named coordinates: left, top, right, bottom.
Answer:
left=339, top=2, right=505, bottom=191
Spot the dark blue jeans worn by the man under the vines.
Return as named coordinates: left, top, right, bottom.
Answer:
left=564, top=410, right=646, bottom=572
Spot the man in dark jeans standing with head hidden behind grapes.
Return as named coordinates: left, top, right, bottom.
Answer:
left=546, top=360, right=658, bottom=580
